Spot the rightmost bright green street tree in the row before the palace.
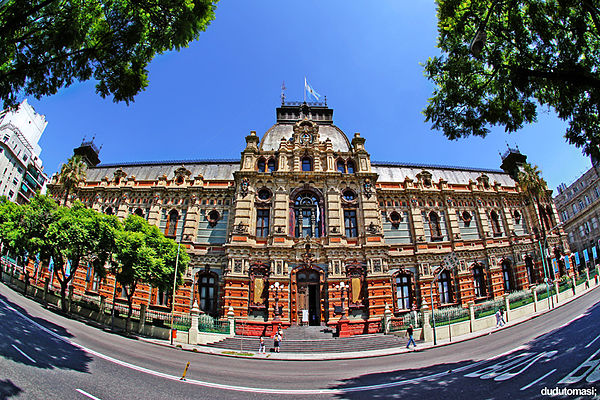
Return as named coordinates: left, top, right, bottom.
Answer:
left=114, top=214, right=189, bottom=327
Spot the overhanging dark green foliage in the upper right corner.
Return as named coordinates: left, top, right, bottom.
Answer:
left=424, top=0, right=600, bottom=157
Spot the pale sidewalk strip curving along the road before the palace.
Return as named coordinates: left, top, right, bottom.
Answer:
left=139, top=285, right=600, bottom=361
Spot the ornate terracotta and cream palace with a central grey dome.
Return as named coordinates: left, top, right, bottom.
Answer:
left=49, top=103, right=568, bottom=334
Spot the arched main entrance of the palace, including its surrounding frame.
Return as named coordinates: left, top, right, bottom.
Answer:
left=291, top=266, right=324, bottom=325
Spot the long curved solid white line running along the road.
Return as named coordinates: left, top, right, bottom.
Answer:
left=0, top=300, right=556, bottom=395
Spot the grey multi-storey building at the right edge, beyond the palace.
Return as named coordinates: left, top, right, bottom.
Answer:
left=554, top=162, right=600, bottom=268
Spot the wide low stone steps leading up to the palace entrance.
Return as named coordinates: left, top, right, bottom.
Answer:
left=206, top=326, right=407, bottom=353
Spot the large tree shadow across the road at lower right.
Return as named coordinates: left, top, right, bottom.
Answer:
left=333, top=303, right=600, bottom=400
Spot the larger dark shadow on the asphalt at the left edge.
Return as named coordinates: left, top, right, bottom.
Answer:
left=0, top=295, right=92, bottom=372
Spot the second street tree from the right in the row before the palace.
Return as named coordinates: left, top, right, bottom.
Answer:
left=46, top=201, right=121, bottom=312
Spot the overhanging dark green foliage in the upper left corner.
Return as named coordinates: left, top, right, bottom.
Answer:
left=0, top=0, right=218, bottom=107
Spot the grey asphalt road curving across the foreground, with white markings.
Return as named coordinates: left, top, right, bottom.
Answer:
left=0, top=284, right=600, bottom=400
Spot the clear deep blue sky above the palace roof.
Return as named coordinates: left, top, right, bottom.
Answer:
left=29, top=0, right=591, bottom=189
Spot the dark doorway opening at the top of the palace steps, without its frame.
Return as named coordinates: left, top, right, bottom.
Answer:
left=296, top=268, right=321, bottom=325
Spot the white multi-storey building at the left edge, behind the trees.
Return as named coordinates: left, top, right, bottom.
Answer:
left=0, top=100, right=48, bottom=204
